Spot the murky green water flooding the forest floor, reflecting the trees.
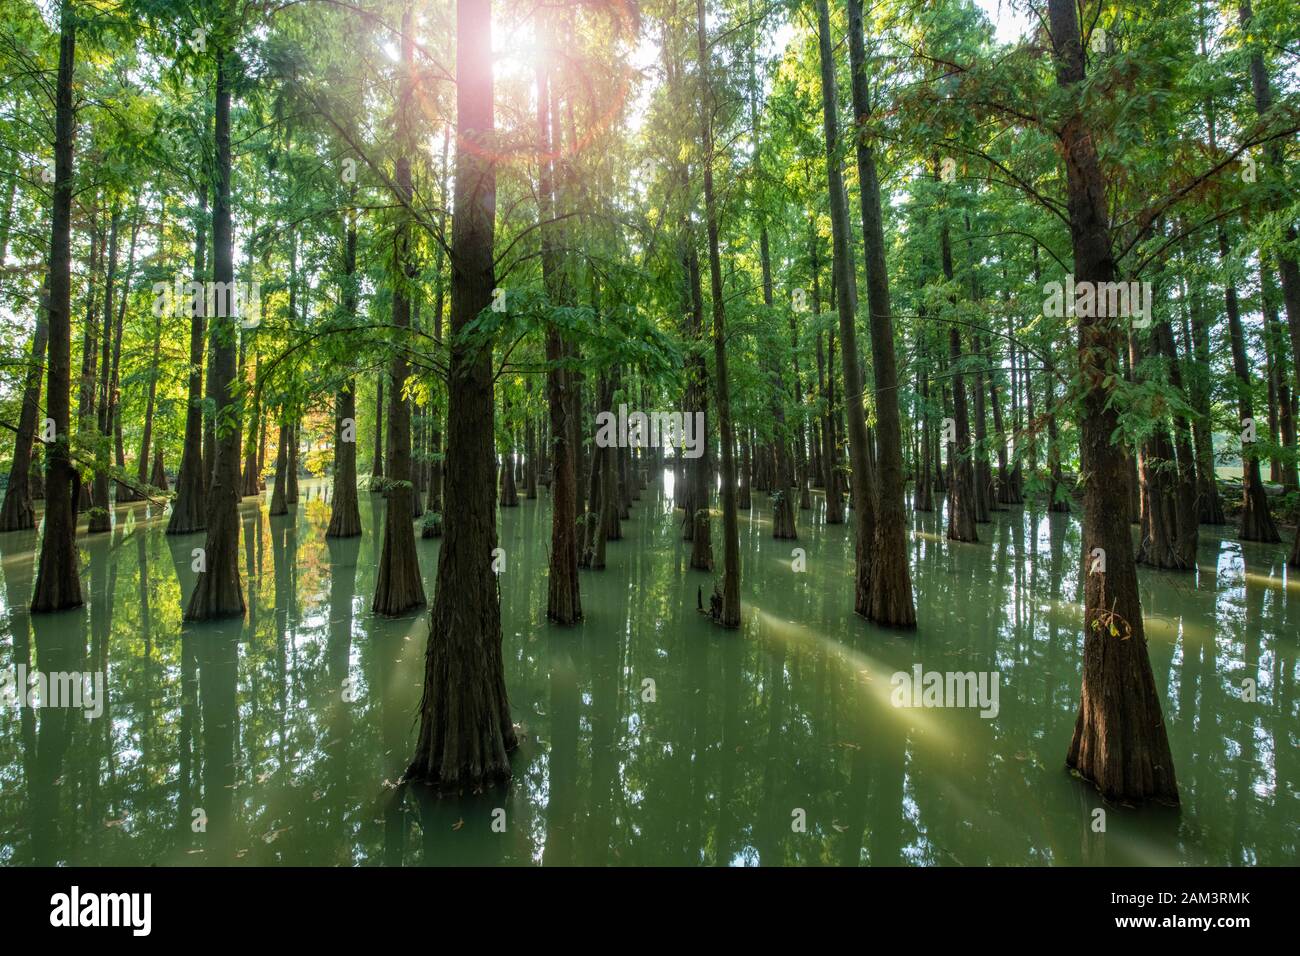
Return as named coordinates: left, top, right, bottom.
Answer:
left=0, top=483, right=1300, bottom=865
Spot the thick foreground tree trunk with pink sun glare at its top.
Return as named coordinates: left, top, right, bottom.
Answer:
left=402, top=0, right=517, bottom=790
